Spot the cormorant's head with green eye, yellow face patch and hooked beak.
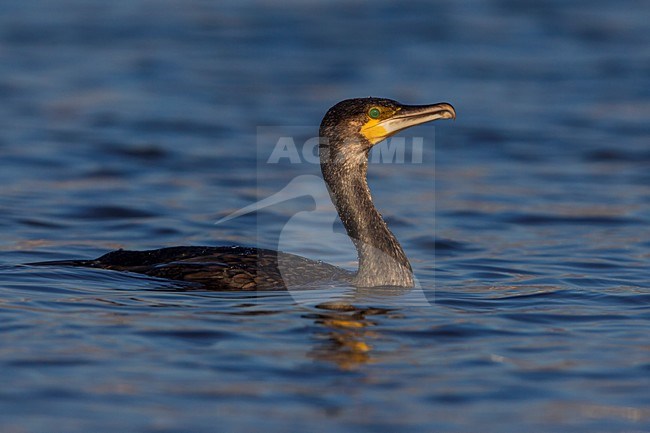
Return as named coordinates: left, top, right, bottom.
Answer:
left=320, top=98, right=456, bottom=163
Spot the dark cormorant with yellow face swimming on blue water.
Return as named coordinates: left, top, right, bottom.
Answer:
left=33, top=98, right=456, bottom=290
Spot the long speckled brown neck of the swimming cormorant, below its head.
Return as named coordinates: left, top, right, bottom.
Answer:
left=319, top=136, right=413, bottom=287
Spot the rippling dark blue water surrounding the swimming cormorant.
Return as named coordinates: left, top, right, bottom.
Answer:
left=0, top=0, right=650, bottom=433
